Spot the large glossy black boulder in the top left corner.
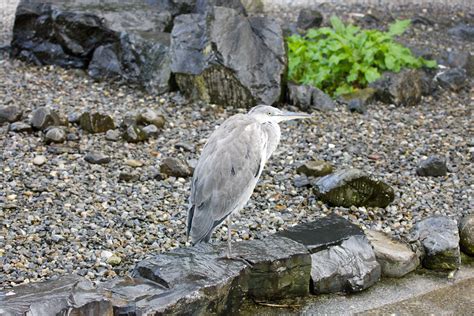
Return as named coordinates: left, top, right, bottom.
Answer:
left=12, top=0, right=172, bottom=93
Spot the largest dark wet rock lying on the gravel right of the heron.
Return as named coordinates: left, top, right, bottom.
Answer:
left=313, top=169, right=395, bottom=207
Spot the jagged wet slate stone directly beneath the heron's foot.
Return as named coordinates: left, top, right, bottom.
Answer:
left=132, top=244, right=246, bottom=314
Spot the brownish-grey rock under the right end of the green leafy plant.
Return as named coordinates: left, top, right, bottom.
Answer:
left=369, top=69, right=425, bottom=106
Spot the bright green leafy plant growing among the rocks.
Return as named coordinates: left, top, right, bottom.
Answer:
left=287, top=16, right=436, bottom=96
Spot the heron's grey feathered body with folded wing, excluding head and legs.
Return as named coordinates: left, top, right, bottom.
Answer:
left=188, top=116, right=267, bottom=242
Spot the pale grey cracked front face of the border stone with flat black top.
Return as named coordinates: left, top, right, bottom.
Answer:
left=311, top=236, right=381, bottom=294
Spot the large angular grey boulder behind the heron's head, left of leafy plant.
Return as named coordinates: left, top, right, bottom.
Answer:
left=171, top=7, right=287, bottom=107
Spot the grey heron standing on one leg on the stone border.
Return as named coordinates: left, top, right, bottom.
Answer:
left=187, top=105, right=311, bottom=258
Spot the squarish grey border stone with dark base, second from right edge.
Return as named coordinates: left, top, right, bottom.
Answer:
left=413, top=216, right=461, bottom=270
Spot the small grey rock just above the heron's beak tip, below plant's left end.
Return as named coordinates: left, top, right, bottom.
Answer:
left=288, top=83, right=336, bottom=111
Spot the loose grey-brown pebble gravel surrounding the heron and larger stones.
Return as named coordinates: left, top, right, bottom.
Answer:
left=0, top=1, right=474, bottom=288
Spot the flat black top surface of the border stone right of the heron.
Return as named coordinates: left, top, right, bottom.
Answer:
left=276, top=213, right=365, bottom=253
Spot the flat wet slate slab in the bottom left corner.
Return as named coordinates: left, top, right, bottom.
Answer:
left=0, top=275, right=114, bottom=315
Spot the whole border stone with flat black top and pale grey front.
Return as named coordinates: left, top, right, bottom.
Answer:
left=277, top=214, right=381, bottom=293
